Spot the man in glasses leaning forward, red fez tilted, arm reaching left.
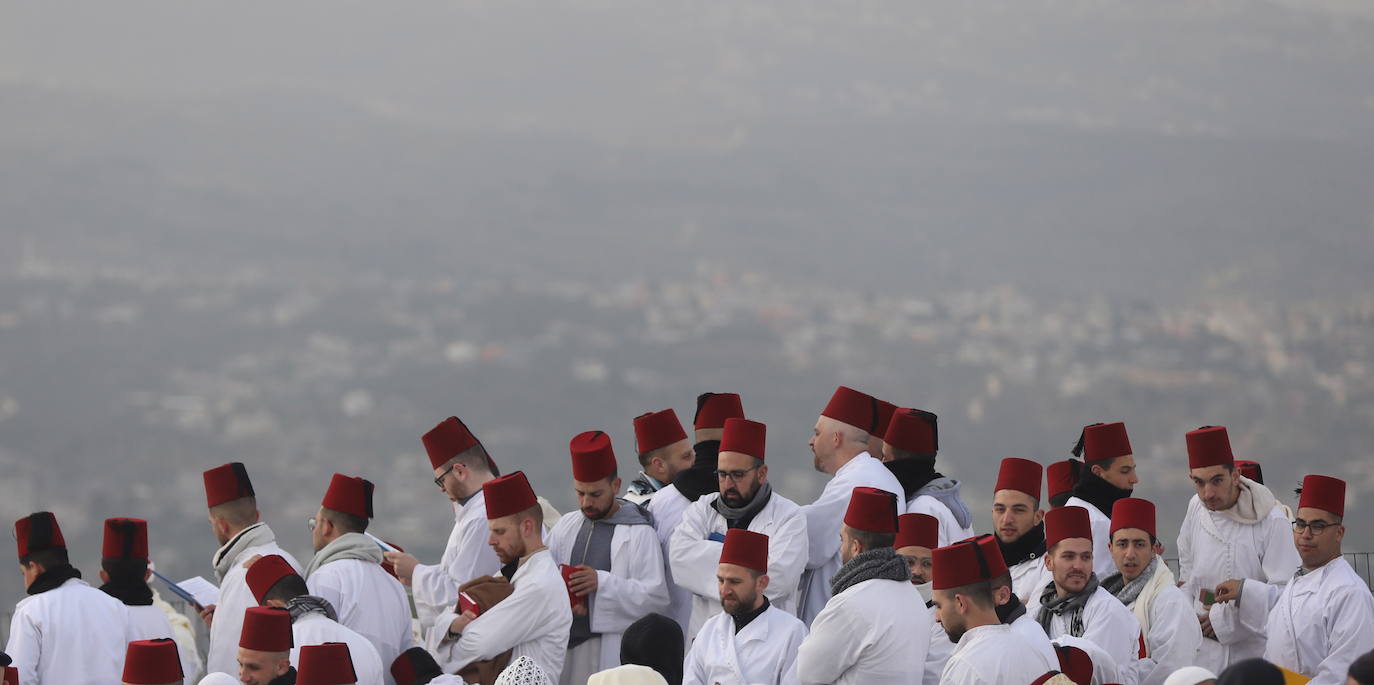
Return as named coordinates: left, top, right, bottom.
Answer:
left=385, top=416, right=502, bottom=634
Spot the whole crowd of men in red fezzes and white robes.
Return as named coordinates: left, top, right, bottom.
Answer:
left=0, top=387, right=1374, bottom=685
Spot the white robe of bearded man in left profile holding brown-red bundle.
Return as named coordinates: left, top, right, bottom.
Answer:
left=425, top=549, right=573, bottom=682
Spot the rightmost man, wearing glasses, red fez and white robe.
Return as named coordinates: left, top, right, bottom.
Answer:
left=1217, top=475, right=1374, bottom=685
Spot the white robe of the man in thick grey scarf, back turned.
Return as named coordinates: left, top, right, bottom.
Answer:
left=797, top=579, right=934, bottom=685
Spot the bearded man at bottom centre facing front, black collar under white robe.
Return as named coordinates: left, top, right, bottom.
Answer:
left=683, top=532, right=807, bottom=685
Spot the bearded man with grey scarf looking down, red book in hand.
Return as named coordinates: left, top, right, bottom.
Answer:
left=548, top=431, right=669, bottom=685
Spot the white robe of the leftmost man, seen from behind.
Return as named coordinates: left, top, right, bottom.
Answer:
left=4, top=578, right=133, bottom=685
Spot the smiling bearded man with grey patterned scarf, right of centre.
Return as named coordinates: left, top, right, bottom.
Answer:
left=1026, top=507, right=1140, bottom=673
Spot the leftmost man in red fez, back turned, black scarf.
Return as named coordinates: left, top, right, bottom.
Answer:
left=4, top=512, right=129, bottom=685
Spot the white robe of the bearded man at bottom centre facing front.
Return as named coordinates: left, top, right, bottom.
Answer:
left=683, top=607, right=807, bottom=685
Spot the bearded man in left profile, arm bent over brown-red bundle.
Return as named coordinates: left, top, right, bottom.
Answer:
left=425, top=471, right=574, bottom=681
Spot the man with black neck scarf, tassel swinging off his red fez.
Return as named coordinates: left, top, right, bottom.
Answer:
left=1065, top=421, right=1140, bottom=578
